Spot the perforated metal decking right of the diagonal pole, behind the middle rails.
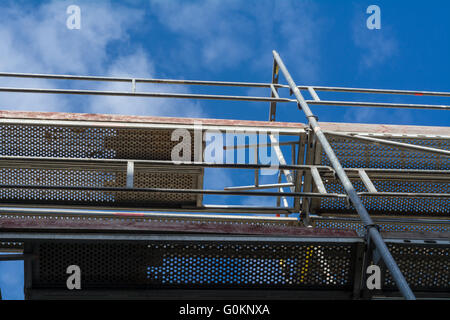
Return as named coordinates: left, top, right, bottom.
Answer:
left=311, top=136, right=450, bottom=216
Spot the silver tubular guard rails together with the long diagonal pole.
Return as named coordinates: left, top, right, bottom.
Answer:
left=0, top=55, right=450, bottom=299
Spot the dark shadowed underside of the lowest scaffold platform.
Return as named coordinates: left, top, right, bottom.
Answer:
left=0, top=218, right=450, bottom=299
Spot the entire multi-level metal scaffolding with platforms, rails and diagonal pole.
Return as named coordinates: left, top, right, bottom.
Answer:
left=0, top=51, right=450, bottom=299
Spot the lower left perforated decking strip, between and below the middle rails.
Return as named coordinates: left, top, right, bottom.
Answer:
left=0, top=163, right=202, bottom=207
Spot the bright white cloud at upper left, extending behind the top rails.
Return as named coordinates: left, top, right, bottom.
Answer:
left=0, top=0, right=201, bottom=116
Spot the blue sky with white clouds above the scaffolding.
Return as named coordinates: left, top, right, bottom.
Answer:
left=0, top=0, right=450, bottom=299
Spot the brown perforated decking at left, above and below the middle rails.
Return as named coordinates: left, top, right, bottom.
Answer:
left=0, top=125, right=203, bottom=207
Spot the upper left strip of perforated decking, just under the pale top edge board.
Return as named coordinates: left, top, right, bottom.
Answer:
left=0, top=124, right=194, bottom=160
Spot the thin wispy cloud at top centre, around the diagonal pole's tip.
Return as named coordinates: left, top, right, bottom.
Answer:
left=150, top=0, right=323, bottom=81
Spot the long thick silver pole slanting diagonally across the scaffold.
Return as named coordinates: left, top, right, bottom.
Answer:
left=273, top=50, right=415, bottom=300
